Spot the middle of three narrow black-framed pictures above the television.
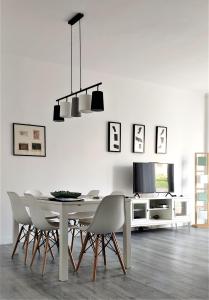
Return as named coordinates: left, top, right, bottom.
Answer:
left=133, top=124, right=145, bottom=153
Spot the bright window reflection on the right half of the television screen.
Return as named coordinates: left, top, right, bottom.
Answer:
left=155, top=163, right=174, bottom=193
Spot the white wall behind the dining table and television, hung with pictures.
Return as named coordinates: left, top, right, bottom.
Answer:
left=0, top=55, right=204, bottom=243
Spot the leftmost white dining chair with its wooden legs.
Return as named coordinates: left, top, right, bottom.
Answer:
left=7, top=192, right=32, bottom=264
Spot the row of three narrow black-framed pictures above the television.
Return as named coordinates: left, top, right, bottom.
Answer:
left=108, top=122, right=167, bottom=154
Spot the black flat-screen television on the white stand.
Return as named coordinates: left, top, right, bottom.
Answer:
left=133, top=162, right=174, bottom=195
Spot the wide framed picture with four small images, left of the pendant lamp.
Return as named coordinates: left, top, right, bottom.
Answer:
left=13, top=123, right=46, bottom=157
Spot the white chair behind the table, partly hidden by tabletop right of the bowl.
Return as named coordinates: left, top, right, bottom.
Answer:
left=68, top=190, right=100, bottom=251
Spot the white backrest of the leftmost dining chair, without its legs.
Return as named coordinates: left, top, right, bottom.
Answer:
left=7, top=192, right=32, bottom=225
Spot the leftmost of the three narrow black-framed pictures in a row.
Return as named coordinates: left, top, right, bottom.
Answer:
left=108, top=122, right=121, bottom=152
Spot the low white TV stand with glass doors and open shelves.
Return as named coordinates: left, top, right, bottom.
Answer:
left=131, top=197, right=191, bottom=228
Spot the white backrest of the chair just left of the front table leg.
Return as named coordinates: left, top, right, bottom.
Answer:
left=25, top=194, right=53, bottom=230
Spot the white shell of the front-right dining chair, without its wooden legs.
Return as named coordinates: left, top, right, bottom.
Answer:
left=87, top=195, right=125, bottom=234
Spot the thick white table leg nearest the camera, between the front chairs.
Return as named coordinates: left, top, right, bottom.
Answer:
left=59, top=205, right=68, bottom=281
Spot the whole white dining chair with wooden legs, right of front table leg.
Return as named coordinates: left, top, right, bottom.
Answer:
left=76, top=195, right=126, bottom=281
